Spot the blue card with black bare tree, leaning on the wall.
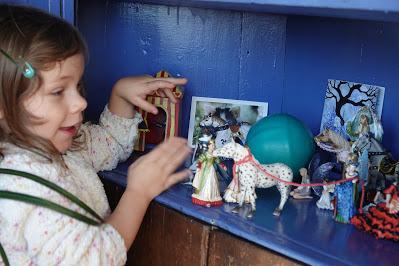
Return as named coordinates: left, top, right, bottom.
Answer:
left=320, top=79, right=385, bottom=139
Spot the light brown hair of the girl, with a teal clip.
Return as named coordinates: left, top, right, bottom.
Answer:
left=0, top=4, right=87, bottom=166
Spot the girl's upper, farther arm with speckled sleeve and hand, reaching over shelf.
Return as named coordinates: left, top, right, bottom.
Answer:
left=81, top=77, right=186, bottom=171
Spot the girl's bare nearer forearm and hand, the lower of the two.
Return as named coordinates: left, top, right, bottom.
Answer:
left=107, top=137, right=191, bottom=248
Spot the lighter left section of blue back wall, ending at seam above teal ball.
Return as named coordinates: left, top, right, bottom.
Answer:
left=78, top=1, right=285, bottom=138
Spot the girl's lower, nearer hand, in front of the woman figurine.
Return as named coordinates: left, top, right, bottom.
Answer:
left=126, top=137, right=192, bottom=201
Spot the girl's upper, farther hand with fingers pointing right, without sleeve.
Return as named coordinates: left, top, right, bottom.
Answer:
left=108, top=76, right=187, bottom=117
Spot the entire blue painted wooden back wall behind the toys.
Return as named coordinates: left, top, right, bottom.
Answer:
left=77, top=1, right=399, bottom=157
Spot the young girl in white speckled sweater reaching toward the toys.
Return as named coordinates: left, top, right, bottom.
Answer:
left=0, top=5, right=191, bottom=265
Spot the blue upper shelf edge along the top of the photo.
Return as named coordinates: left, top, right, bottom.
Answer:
left=141, top=0, right=399, bottom=21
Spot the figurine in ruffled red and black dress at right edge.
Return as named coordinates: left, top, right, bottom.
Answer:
left=351, top=179, right=399, bottom=241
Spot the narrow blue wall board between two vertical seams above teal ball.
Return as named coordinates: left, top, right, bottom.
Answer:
left=239, top=13, right=286, bottom=114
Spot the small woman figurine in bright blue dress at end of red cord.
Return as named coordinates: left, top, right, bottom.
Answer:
left=334, top=153, right=359, bottom=223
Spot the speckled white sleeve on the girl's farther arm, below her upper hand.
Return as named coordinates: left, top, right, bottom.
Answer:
left=81, top=106, right=142, bottom=172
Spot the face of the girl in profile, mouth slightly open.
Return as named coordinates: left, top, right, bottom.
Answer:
left=23, top=54, right=87, bottom=153
